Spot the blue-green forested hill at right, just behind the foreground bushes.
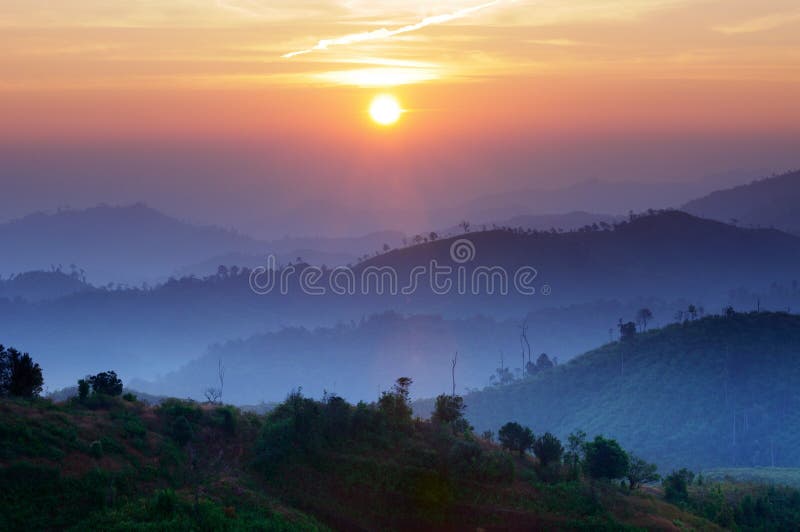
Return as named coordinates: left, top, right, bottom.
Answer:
left=454, top=313, right=800, bottom=469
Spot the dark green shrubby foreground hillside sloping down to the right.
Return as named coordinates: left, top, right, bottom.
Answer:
left=0, top=393, right=716, bottom=531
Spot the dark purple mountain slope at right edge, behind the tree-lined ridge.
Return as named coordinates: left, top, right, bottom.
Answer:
left=682, top=170, right=800, bottom=234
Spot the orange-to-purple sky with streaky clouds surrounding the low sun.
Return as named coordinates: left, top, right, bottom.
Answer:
left=0, top=0, right=800, bottom=232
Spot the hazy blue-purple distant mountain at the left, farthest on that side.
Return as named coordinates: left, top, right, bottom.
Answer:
left=0, top=203, right=402, bottom=285
